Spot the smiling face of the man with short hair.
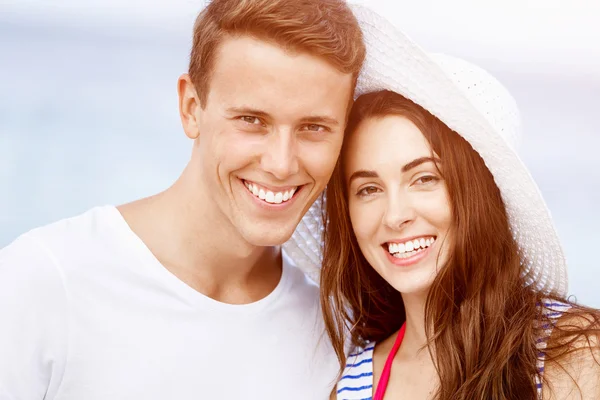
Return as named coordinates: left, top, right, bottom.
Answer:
left=183, top=37, right=353, bottom=246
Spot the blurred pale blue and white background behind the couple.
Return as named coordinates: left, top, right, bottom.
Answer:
left=0, top=0, right=600, bottom=307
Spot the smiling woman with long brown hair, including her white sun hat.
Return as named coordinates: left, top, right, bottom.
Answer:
left=288, top=3, right=600, bottom=400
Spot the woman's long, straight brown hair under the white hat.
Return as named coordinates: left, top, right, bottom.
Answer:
left=321, top=91, right=599, bottom=400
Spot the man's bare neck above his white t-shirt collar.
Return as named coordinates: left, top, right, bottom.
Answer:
left=119, top=175, right=282, bottom=304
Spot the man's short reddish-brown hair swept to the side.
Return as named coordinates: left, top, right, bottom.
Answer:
left=189, top=0, right=366, bottom=107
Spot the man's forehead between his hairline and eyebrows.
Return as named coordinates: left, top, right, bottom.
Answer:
left=202, top=36, right=353, bottom=119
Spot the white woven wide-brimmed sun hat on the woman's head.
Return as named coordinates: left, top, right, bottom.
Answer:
left=283, top=5, right=568, bottom=296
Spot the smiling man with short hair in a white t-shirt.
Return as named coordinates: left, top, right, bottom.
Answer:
left=0, top=0, right=365, bottom=400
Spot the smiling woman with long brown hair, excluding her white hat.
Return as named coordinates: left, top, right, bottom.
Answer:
left=321, top=91, right=600, bottom=400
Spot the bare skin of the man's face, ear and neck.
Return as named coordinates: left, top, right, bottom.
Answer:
left=118, top=36, right=353, bottom=304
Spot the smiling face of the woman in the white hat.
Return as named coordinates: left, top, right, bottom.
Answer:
left=344, top=115, right=451, bottom=294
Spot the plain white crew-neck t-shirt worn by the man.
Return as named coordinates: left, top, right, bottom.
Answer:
left=0, top=206, right=338, bottom=400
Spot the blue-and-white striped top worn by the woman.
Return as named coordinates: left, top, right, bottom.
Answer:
left=337, top=301, right=570, bottom=400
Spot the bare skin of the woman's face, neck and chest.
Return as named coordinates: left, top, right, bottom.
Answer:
left=344, top=116, right=451, bottom=399
